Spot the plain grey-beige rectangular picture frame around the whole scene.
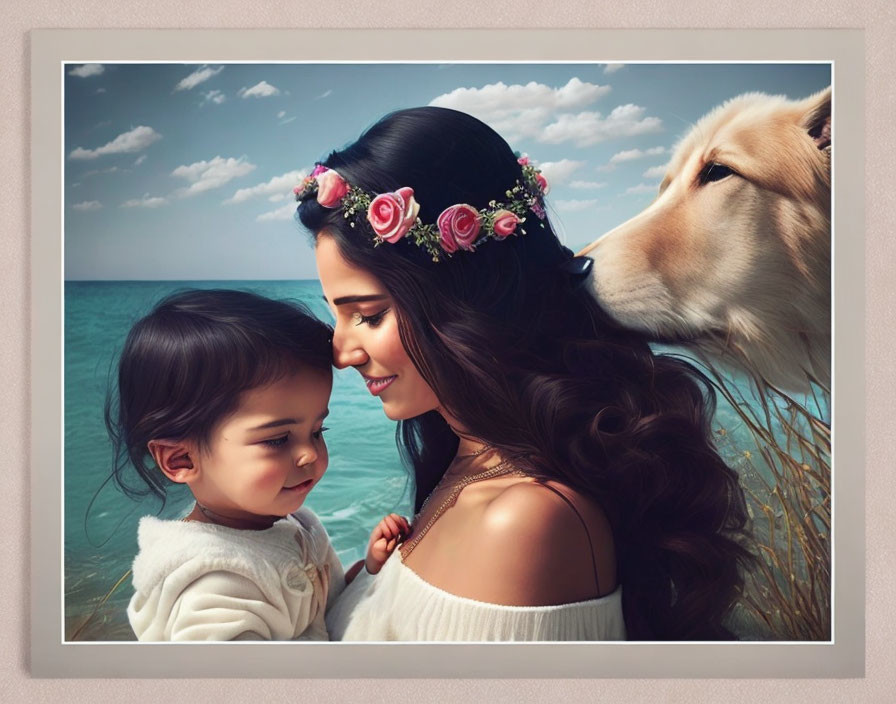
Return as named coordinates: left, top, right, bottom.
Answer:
left=31, top=30, right=864, bottom=677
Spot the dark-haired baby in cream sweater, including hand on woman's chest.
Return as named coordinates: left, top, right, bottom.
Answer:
left=107, top=290, right=407, bottom=641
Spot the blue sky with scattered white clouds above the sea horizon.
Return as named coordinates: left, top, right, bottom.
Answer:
left=63, top=63, right=830, bottom=280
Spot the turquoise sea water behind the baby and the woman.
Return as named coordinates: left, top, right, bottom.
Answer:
left=64, top=280, right=829, bottom=640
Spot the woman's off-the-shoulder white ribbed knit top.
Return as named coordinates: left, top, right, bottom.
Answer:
left=327, top=550, right=625, bottom=641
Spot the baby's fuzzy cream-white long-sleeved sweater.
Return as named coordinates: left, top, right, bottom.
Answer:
left=128, top=508, right=345, bottom=641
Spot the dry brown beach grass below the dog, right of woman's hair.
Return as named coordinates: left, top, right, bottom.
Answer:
left=708, top=367, right=832, bottom=641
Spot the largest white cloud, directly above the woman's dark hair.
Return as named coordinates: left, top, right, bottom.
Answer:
left=429, top=77, right=610, bottom=141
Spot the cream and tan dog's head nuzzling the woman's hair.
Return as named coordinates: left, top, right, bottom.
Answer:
left=579, top=87, right=831, bottom=391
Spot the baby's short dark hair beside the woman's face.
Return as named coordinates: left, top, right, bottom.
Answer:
left=105, top=289, right=333, bottom=501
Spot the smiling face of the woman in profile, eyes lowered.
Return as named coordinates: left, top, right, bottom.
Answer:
left=315, top=233, right=439, bottom=420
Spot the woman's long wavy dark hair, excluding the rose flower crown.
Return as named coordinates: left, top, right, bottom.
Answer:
left=298, top=107, right=747, bottom=640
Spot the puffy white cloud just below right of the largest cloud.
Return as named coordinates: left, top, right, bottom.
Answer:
left=541, top=103, right=663, bottom=147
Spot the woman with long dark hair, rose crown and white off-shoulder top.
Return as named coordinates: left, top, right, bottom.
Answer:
left=296, top=107, right=747, bottom=640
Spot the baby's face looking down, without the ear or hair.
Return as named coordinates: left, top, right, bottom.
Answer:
left=191, top=369, right=333, bottom=518
